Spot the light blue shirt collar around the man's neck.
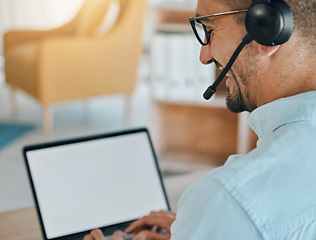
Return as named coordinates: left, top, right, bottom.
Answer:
left=248, top=91, right=316, bottom=138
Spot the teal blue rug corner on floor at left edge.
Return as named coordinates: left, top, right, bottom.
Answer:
left=0, top=123, right=35, bottom=151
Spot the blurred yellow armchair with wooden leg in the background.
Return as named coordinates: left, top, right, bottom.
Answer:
left=4, top=0, right=147, bottom=130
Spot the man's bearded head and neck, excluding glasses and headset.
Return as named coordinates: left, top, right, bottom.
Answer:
left=196, top=0, right=316, bottom=112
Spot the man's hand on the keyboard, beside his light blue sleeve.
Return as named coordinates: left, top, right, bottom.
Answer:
left=125, top=211, right=176, bottom=240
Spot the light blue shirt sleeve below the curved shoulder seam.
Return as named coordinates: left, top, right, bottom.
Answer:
left=171, top=177, right=262, bottom=240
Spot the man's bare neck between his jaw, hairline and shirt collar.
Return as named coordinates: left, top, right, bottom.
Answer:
left=257, top=43, right=316, bottom=106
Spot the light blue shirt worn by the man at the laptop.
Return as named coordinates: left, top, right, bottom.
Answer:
left=171, top=91, right=316, bottom=240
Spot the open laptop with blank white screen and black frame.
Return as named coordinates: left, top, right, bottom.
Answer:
left=23, top=128, right=170, bottom=240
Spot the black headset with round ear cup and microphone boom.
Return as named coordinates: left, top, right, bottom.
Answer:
left=203, top=0, right=295, bottom=100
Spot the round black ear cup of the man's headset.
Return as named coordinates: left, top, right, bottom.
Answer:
left=245, top=0, right=295, bottom=46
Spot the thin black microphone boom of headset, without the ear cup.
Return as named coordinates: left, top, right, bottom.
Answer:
left=203, top=34, right=252, bottom=100
